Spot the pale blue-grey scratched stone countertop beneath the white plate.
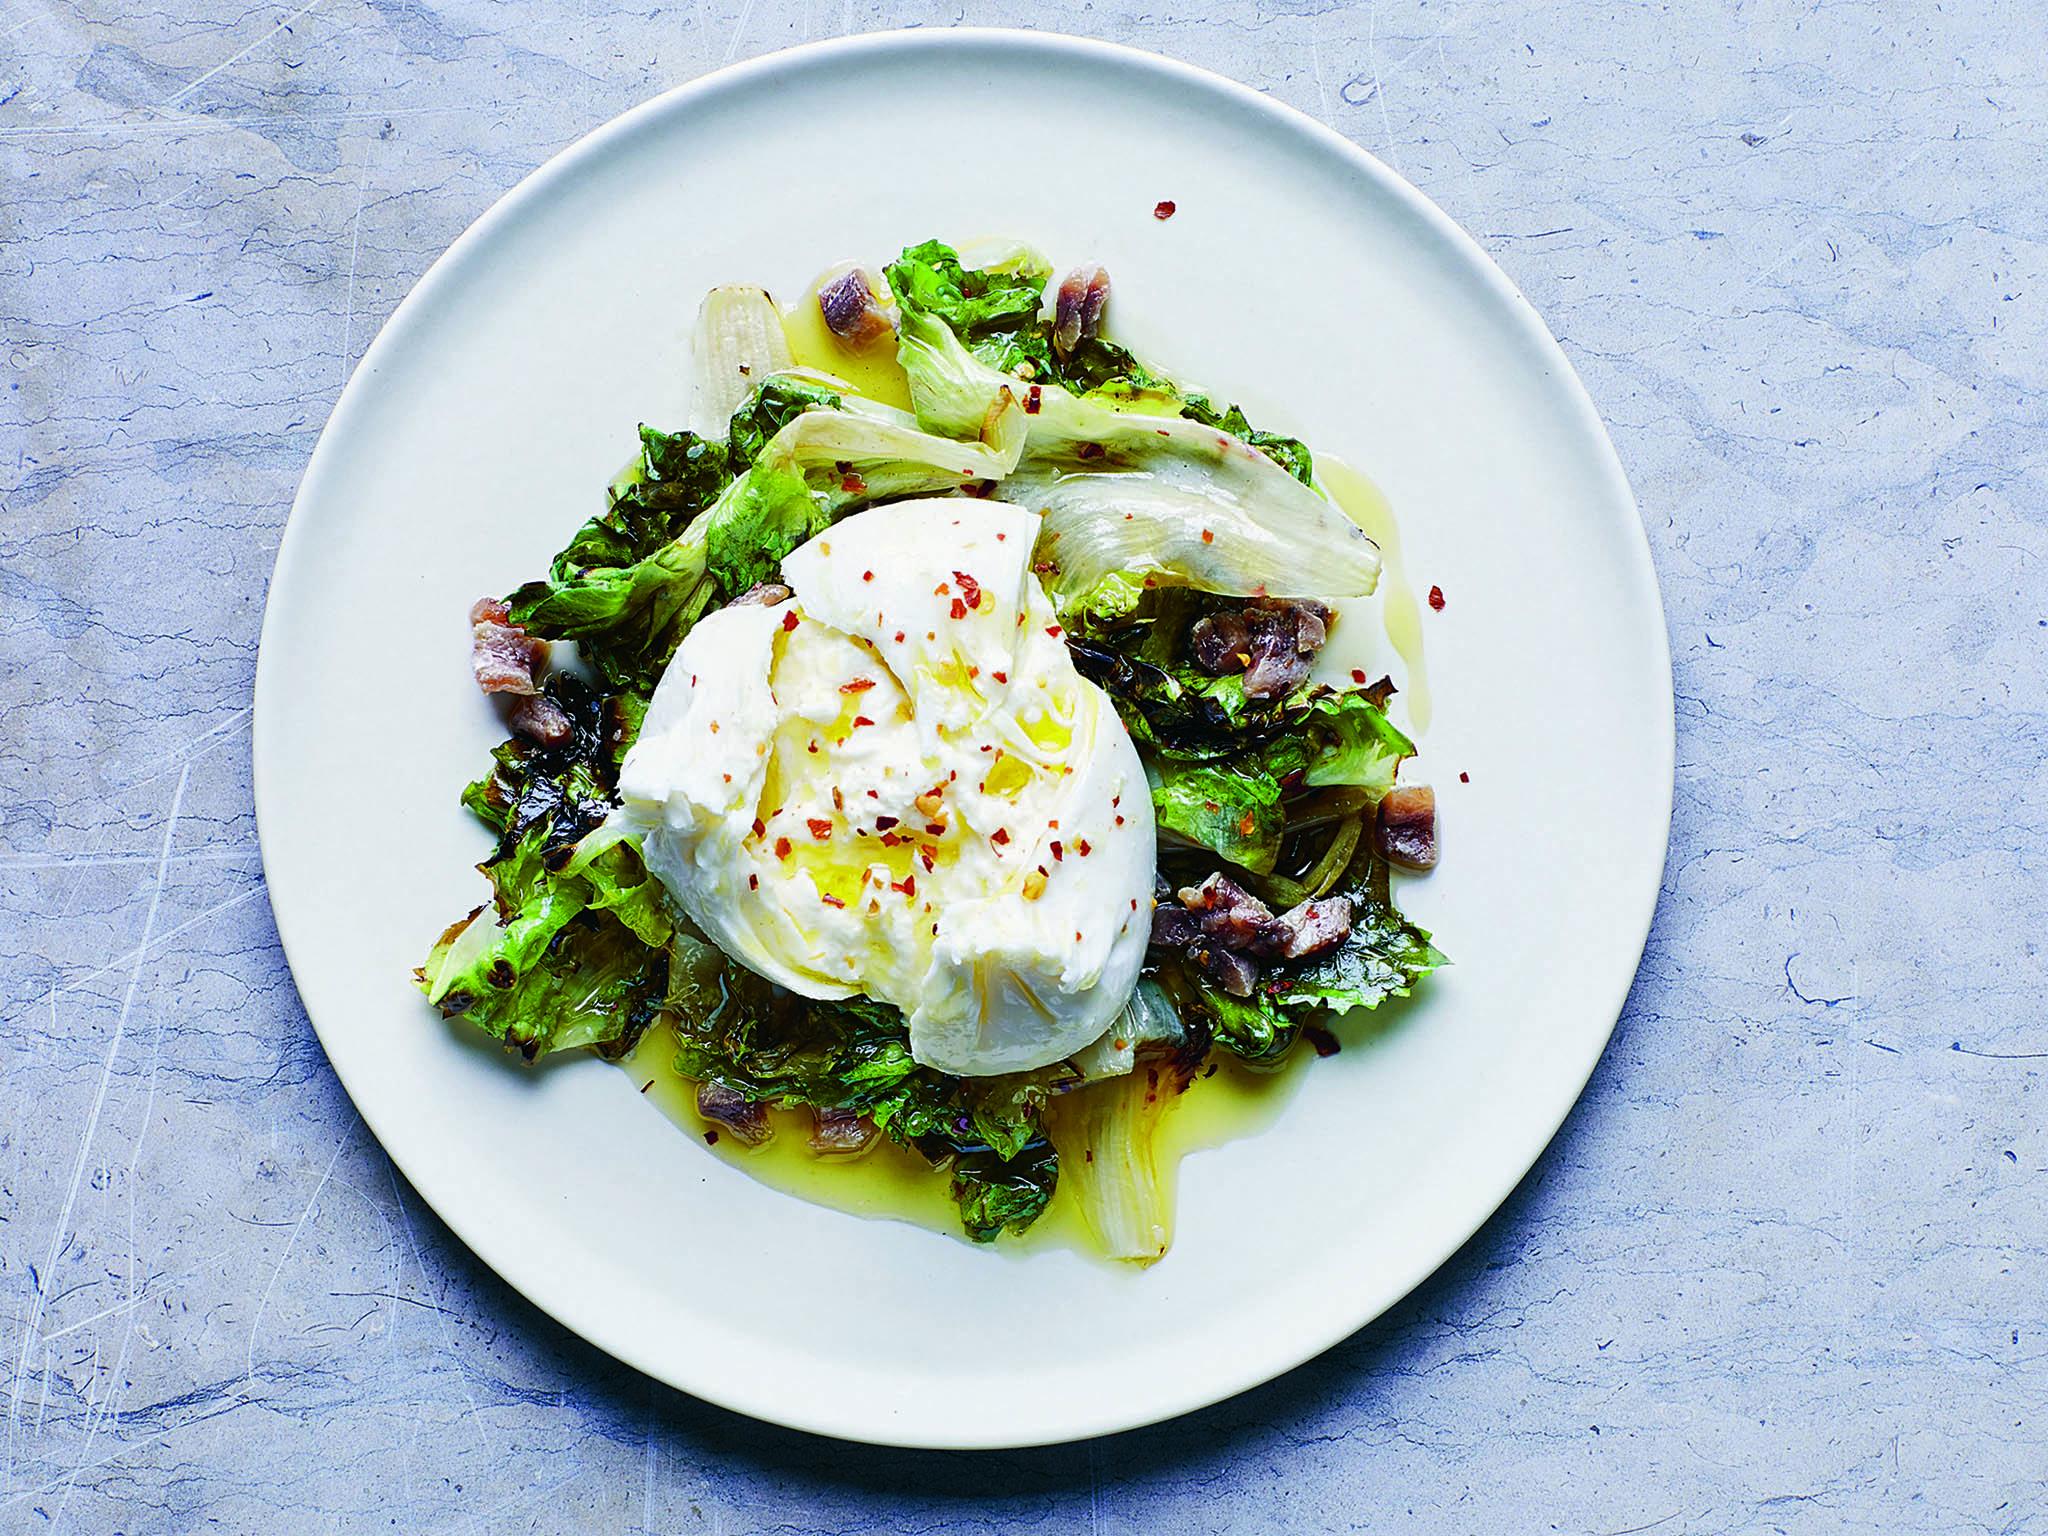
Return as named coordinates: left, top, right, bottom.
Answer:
left=0, top=0, right=2048, bottom=1536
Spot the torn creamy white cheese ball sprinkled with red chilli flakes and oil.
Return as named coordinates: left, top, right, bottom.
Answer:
left=618, top=498, right=1155, bottom=1075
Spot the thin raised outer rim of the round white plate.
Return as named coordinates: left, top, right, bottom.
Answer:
left=250, top=27, right=1677, bottom=1450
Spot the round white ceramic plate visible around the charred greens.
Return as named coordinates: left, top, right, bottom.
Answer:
left=256, top=33, right=1671, bottom=1446
